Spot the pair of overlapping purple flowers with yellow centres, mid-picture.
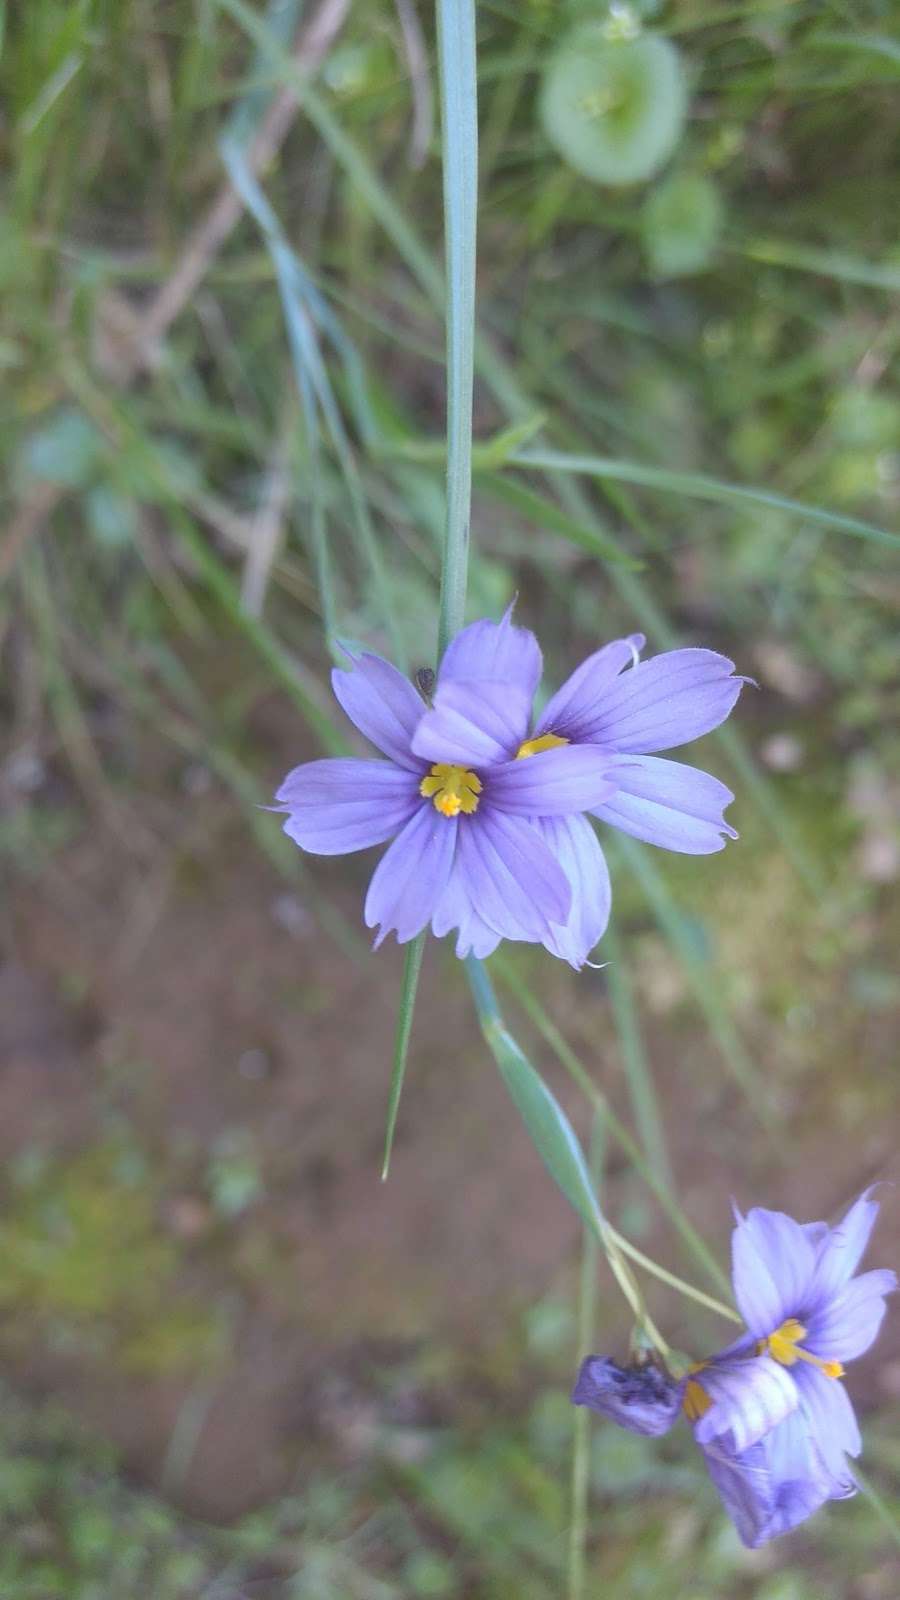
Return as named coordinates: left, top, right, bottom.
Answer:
left=277, top=608, right=745, bottom=968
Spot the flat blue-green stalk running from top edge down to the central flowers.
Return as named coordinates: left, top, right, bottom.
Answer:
left=437, top=0, right=479, bottom=656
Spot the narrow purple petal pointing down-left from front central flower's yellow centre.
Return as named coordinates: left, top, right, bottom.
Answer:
left=365, top=802, right=458, bottom=949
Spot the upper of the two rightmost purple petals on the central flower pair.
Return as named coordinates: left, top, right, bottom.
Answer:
left=566, top=650, right=746, bottom=755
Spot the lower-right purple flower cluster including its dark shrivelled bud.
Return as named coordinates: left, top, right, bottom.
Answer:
left=572, top=1190, right=897, bottom=1547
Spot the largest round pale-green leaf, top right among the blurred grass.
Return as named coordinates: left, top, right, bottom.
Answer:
left=540, top=26, right=687, bottom=184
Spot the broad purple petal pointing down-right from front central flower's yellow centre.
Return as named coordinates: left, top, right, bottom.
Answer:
left=458, top=802, right=572, bottom=944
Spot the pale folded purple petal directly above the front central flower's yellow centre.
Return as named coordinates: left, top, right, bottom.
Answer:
left=413, top=678, right=536, bottom=768
